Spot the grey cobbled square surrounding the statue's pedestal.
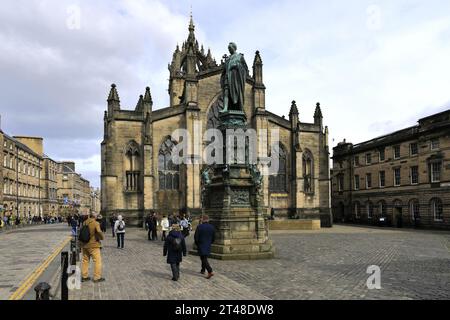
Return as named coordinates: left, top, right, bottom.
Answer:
left=57, top=225, right=450, bottom=300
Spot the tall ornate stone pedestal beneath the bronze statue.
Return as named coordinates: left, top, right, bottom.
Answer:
left=191, top=110, right=274, bottom=260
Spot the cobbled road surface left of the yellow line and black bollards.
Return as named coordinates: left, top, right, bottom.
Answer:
left=0, top=224, right=70, bottom=300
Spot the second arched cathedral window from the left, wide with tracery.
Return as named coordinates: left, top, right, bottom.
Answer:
left=158, top=137, right=180, bottom=190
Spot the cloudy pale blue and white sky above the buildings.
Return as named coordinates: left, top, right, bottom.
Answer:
left=0, top=0, right=450, bottom=186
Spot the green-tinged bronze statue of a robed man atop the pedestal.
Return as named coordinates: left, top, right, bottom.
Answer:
left=220, top=42, right=248, bottom=112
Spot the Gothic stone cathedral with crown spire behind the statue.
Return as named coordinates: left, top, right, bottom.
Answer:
left=101, top=18, right=331, bottom=227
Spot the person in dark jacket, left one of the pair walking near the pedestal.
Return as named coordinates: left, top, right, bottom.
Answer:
left=163, top=224, right=186, bottom=281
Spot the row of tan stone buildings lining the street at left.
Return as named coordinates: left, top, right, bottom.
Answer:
left=0, top=120, right=96, bottom=219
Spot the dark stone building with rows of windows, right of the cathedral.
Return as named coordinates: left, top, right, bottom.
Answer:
left=332, top=110, right=450, bottom=229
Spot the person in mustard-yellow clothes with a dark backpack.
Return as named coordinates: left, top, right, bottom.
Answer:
left=81, top=213, right=105, bottom=282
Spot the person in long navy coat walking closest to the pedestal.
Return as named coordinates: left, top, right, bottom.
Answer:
left=194, top=215, right=215, bottom=279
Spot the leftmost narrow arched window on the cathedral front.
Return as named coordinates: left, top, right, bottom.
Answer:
left=125, top=140, right=141, bottom=191
